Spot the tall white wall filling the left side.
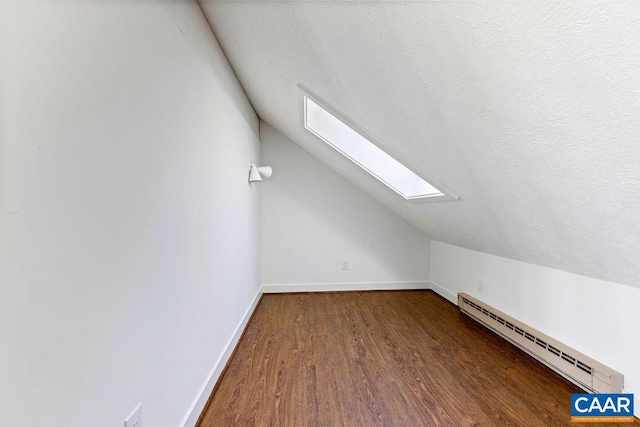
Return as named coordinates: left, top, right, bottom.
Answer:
left=0, top=0, right=260, bottom=427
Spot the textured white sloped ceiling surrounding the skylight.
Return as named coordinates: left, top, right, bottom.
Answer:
left=200, top=0, right=640, bottom=287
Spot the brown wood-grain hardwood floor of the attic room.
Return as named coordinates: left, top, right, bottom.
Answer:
left=199, top=291, right=639, bottom=427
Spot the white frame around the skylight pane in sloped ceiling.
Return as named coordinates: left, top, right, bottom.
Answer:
left=297, top=84, right=459, bottom=203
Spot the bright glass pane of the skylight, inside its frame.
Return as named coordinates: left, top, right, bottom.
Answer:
left=304, top=95, right=445, bottom=200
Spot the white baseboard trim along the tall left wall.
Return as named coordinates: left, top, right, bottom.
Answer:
left=180, top=288, right=262, bottom=427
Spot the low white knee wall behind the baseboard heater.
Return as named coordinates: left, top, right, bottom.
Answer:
left=431, top=240, right=640, bottom=416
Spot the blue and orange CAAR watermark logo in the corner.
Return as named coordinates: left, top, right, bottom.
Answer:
left=571, top=394, right=633, bottom=423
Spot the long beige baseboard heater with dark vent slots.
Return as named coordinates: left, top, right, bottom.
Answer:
left=458, top=293, right=624, bottom=393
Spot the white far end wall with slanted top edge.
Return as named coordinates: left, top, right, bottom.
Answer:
left=260, top=122, right=429, bottom=290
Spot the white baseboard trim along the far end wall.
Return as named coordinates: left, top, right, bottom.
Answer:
left=262, top=282, right=430, bottom=294
